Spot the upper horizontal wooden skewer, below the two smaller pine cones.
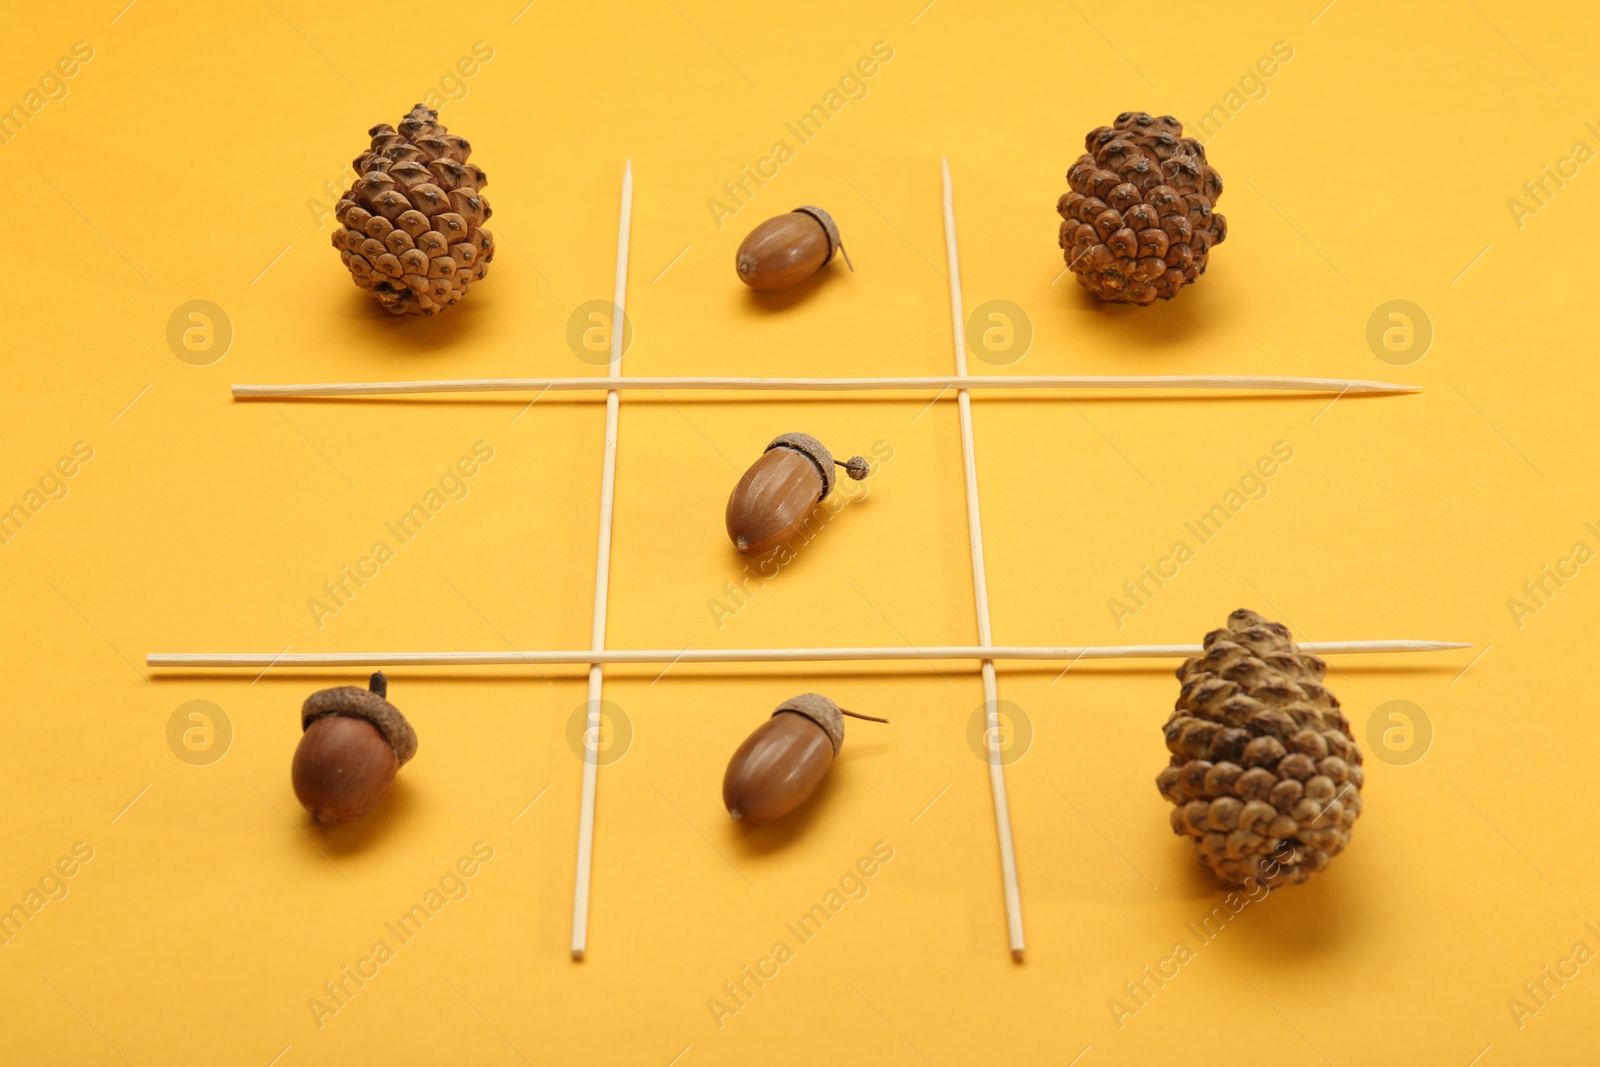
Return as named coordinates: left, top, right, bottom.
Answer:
left=234, top=374, right=1421, bottom=398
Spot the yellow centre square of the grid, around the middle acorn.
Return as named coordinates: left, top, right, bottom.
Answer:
left=608, top=397, right=974, bottom=655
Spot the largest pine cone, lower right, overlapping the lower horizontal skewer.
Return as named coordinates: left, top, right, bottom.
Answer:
left=1155, top=608, right=1365, bottom=885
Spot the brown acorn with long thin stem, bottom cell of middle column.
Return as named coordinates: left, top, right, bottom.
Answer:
left=722, top=693, right=890, bottom=825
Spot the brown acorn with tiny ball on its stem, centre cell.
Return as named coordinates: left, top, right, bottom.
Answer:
left=725, top=434, right=870, bottom=555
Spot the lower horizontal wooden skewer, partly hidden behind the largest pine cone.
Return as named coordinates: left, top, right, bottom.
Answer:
left=144, top=641, right=1472, bottom=669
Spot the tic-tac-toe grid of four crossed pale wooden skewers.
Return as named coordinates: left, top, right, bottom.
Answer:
left=146, top=162, right=1440, bottom=961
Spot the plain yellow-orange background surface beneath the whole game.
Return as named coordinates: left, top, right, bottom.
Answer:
left=0, top=0, right=1600, bottom=1067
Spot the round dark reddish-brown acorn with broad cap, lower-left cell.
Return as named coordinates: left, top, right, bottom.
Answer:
left=290, top=670, right=416, bottom=822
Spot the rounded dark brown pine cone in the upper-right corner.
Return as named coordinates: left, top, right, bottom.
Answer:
left=1056, top=110, right=1227, bottom=304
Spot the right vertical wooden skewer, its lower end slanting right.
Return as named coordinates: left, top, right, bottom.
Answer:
left=941, top=158, right=1026, bottom=963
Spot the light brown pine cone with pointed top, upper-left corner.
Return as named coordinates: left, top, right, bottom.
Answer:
left=333, top=104, right=494, bottom=315
